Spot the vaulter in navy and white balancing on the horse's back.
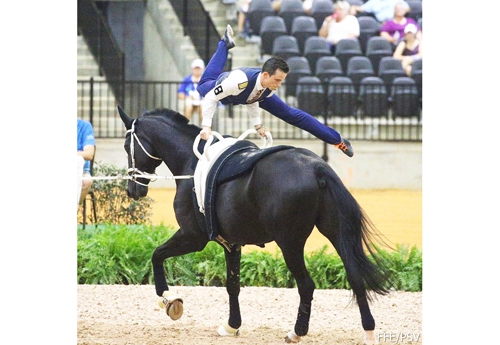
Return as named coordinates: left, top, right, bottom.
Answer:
left=198, top=25, right=354, bottom=157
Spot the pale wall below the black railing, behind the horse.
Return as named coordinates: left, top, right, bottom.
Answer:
left=95, top=139, right=422, bottom=190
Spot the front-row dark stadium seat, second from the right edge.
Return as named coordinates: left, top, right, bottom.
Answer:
left=358, top=77, right=389, bottom=118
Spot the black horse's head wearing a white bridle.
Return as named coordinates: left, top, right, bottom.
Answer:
left=118, top=105, right=162, bottom=200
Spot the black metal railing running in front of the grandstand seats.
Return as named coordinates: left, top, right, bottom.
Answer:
left=77, top=78, right=422, bottom=141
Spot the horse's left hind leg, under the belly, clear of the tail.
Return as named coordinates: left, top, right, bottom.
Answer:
left=276, top=238, right=316, bottom=343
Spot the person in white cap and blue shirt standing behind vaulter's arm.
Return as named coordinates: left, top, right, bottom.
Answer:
left=177, top=59, right=205, bottom=123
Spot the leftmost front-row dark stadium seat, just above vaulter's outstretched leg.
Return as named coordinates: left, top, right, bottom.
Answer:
left=296, top=76, right=325, bottom=116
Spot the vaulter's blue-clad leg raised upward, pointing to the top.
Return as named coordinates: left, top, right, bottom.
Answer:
left=196, top=25, right=235, bottom=97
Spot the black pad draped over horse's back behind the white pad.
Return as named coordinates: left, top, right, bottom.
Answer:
left=205, top=140, right=293, bottom=240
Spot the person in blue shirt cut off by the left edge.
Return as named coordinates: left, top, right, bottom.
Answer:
left=76, top=119, right=95, bottom=205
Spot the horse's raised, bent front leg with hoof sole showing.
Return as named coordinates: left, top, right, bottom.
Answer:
left=151, top=228, right=208, bottom=320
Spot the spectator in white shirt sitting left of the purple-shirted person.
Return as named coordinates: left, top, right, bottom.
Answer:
left=318, top=0, right=359, bottom=54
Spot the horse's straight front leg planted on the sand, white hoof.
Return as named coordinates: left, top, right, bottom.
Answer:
left=217, top=246, right=241, bottom=336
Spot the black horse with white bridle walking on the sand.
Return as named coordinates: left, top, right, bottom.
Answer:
left=118, top=106, right=390, bottom=344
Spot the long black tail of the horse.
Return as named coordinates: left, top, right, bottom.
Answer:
left=318, top=165, right=392, bottom=300
